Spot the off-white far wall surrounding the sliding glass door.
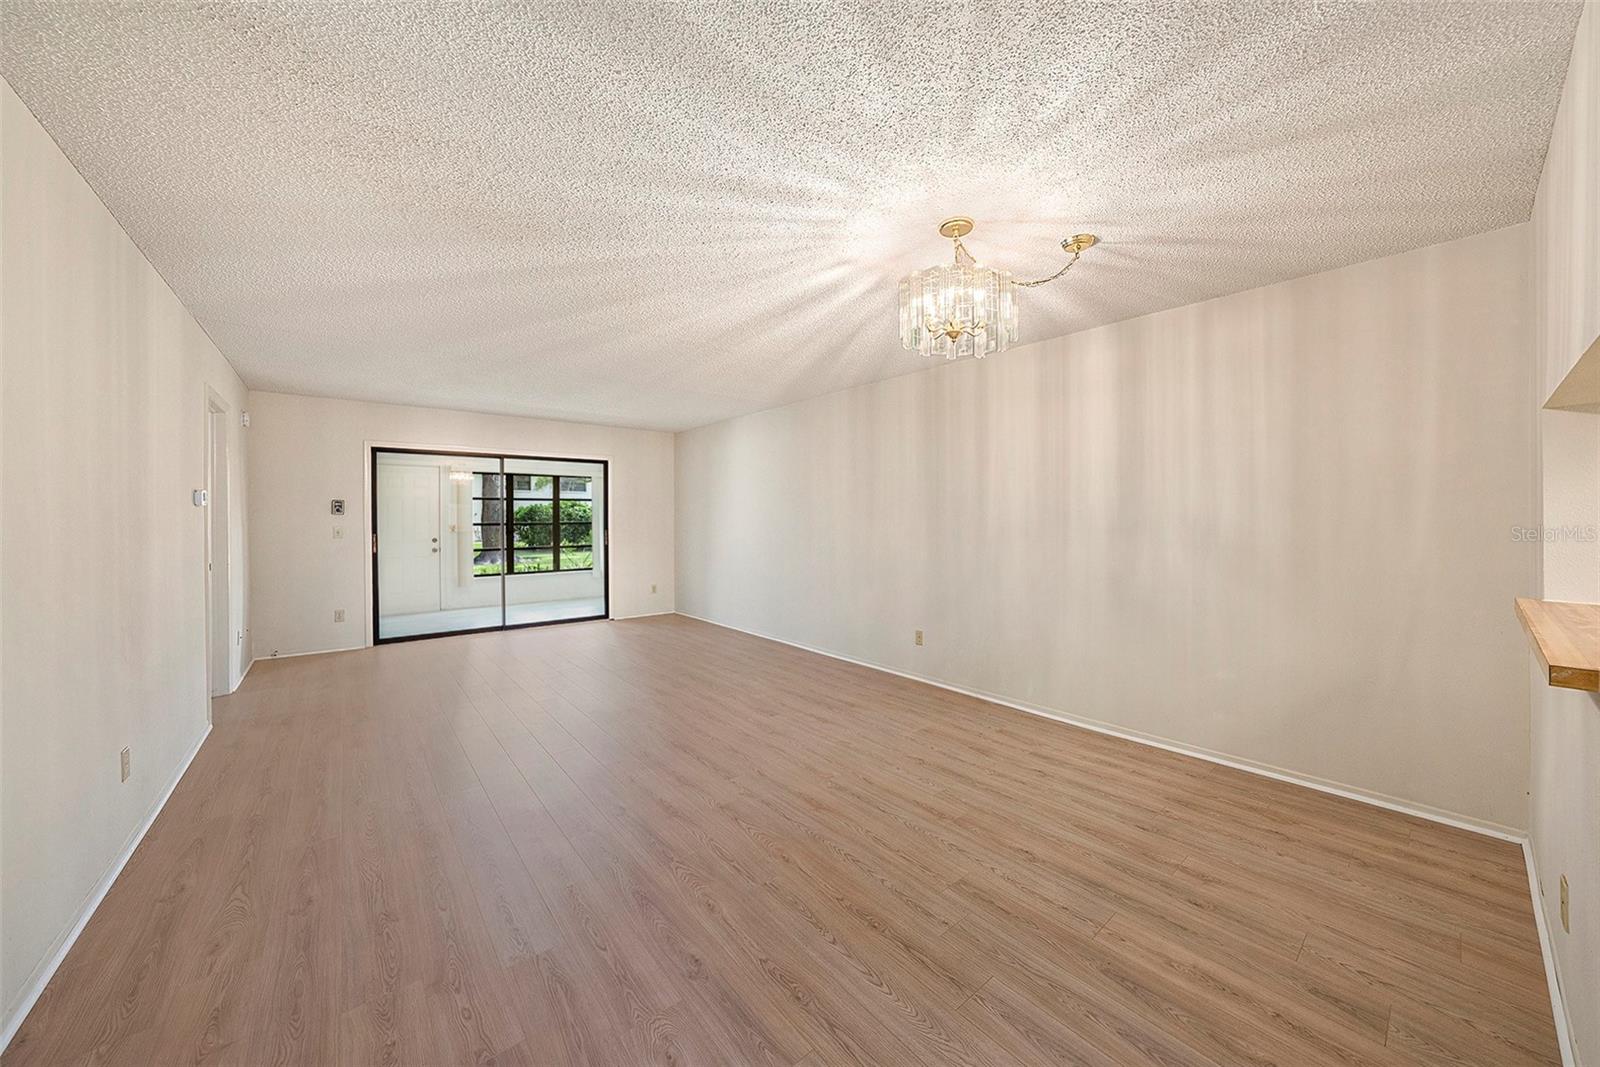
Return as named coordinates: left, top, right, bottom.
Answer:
left=250, top=392, right=674, bottom=656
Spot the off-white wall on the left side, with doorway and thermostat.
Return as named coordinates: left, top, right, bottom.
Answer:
left=0, top=85, right=246, bottom=1032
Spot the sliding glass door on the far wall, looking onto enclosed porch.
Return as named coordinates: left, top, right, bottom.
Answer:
left=371, top=448, right=610, bottom=641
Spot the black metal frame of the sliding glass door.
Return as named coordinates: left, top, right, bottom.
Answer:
left=366, top=445, right=611, bottom=645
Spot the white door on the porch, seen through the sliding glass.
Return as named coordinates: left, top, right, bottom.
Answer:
left=378, top=464, right=440, bottom=616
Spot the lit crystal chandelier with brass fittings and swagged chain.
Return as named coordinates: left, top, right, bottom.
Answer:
left=901, top=216, right=1099, bottom=360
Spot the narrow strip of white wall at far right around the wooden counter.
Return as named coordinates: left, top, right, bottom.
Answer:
left=1530, top=5, right=1600, bottom=1064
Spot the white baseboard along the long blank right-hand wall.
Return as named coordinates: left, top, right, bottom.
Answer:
left=675, top=611, right=1528, bottom=845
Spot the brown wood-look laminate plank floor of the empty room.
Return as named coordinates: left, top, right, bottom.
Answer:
left=3, top=616, right=1558, bottom=1067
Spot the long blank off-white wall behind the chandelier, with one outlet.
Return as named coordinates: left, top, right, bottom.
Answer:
left=677, top=226, right=1536, bottom=827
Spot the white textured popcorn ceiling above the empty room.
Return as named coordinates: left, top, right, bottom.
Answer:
left=0, top=0, right=1579, bottom=429
